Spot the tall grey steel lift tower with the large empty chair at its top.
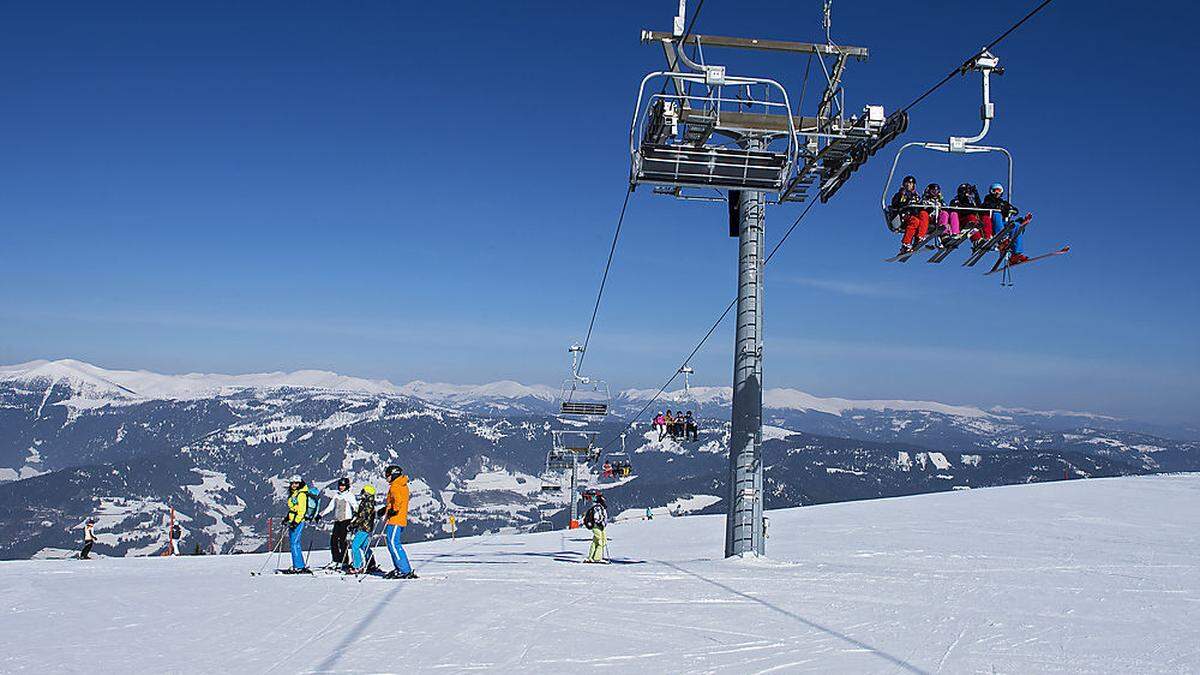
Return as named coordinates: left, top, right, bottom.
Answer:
left=629, top=0, right=907, bottom=557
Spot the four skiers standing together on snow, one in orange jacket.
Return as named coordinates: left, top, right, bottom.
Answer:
left=280, top=465, right=416, bottom=579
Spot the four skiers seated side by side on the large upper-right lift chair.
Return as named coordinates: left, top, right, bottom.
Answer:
left=888, top=175, right=1033, bottom=265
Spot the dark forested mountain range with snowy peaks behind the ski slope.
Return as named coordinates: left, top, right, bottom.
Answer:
left=0, top=360, right=1200, bottom=557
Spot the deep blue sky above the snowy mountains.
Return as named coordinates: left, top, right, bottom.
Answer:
left=0, top=0, right=1200, bottom=422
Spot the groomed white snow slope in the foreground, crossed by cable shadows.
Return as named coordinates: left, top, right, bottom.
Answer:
left=0, top=474, right=1200, bottom=673
